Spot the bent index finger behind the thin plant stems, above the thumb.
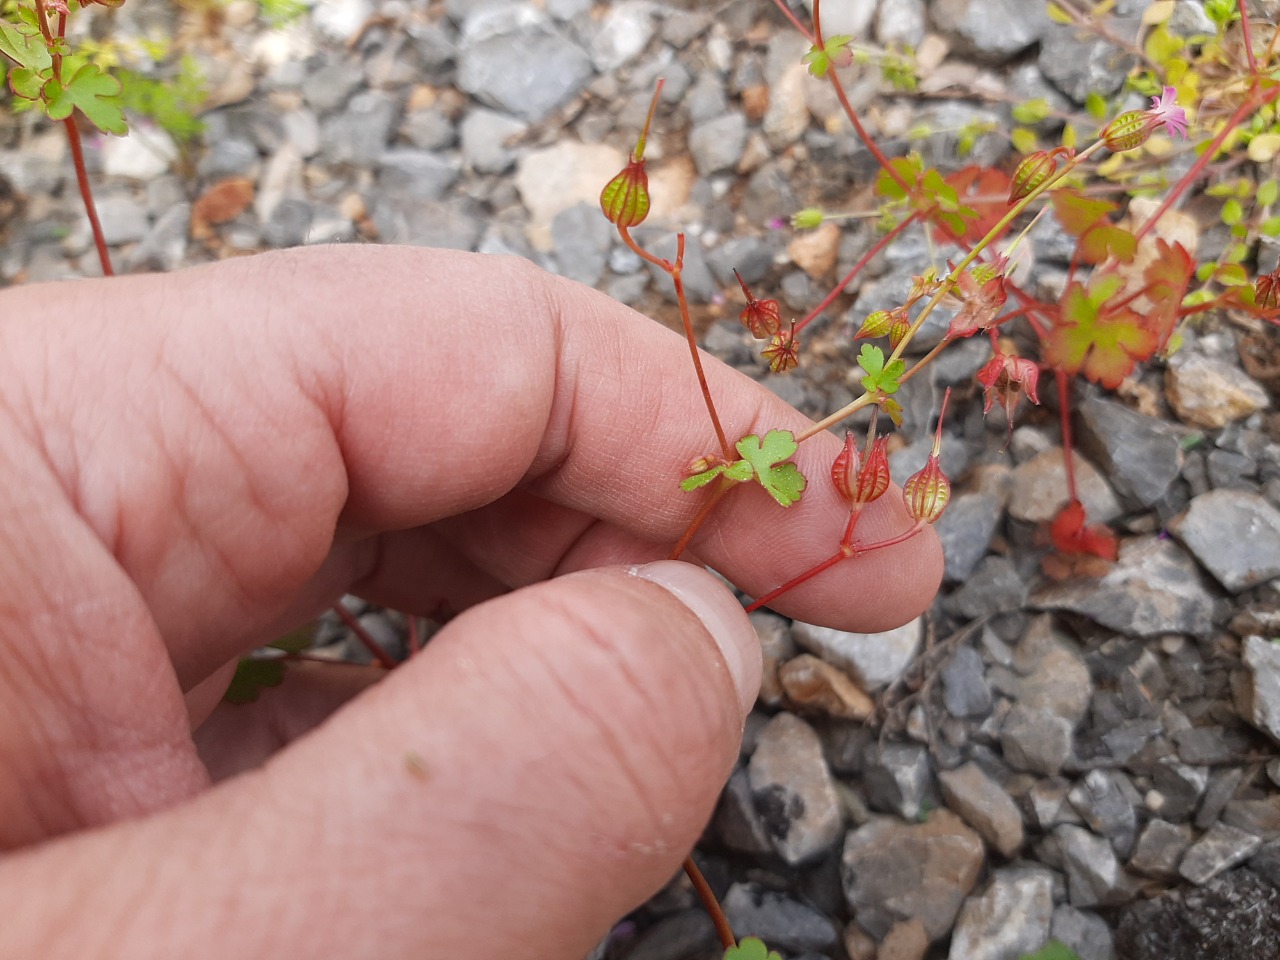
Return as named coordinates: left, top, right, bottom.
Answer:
left=6, top=247, right=941, bottom=675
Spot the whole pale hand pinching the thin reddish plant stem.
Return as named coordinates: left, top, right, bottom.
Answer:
left=0, top=247, right=942, bottom=960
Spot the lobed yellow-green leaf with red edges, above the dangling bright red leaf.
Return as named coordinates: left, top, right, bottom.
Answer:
left=1044, top=274, right=1160, bottom=389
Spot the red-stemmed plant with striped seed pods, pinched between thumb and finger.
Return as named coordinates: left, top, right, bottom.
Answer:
left=602, top=0, right=1280, bottom=960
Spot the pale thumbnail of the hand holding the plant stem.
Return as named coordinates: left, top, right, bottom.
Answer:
left=627, top=561, right=762, bottom=717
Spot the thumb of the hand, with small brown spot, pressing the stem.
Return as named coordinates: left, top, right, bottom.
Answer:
left=0, top=561, right=760, bottom=960
